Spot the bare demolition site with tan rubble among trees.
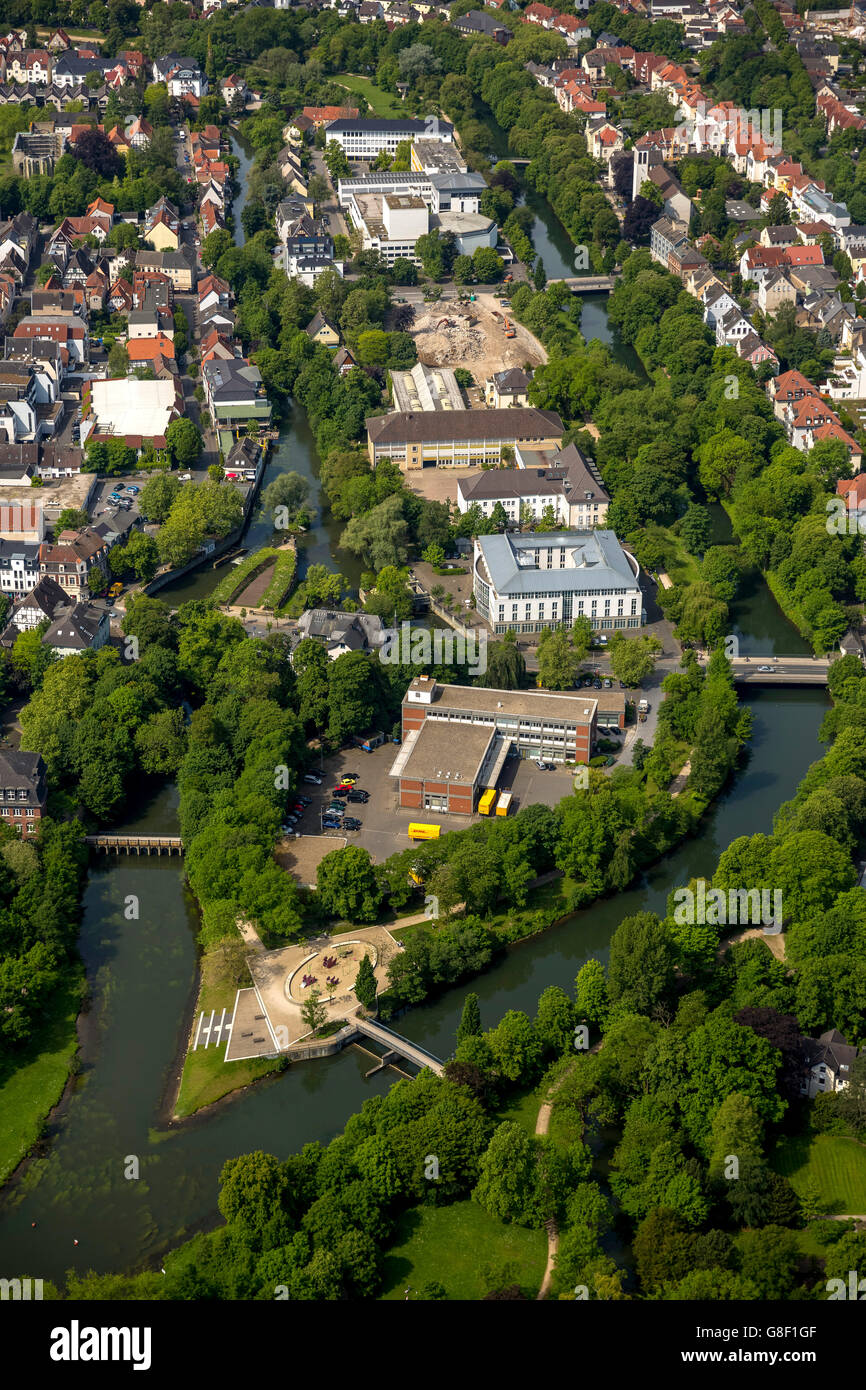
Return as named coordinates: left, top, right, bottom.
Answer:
left=409, top=295, right=548, bottom=384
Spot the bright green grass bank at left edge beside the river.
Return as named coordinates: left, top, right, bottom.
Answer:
left=0, top=974, right=82, bottom=1183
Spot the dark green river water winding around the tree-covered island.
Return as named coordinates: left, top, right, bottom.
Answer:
left=0, top=113, right=827, bottom=1280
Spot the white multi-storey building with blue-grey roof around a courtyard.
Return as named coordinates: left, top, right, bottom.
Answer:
left=473, top=530, right=644, bottom=634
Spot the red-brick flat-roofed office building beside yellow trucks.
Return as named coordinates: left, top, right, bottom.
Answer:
left=391, top=676, right=598, bottom=816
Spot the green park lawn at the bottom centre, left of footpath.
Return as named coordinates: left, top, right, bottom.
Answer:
left=379, top=1201, right=548, bottom=1301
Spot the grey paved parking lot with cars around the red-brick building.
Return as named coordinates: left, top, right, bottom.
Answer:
left=284, top=742, right=589, bottom=863
